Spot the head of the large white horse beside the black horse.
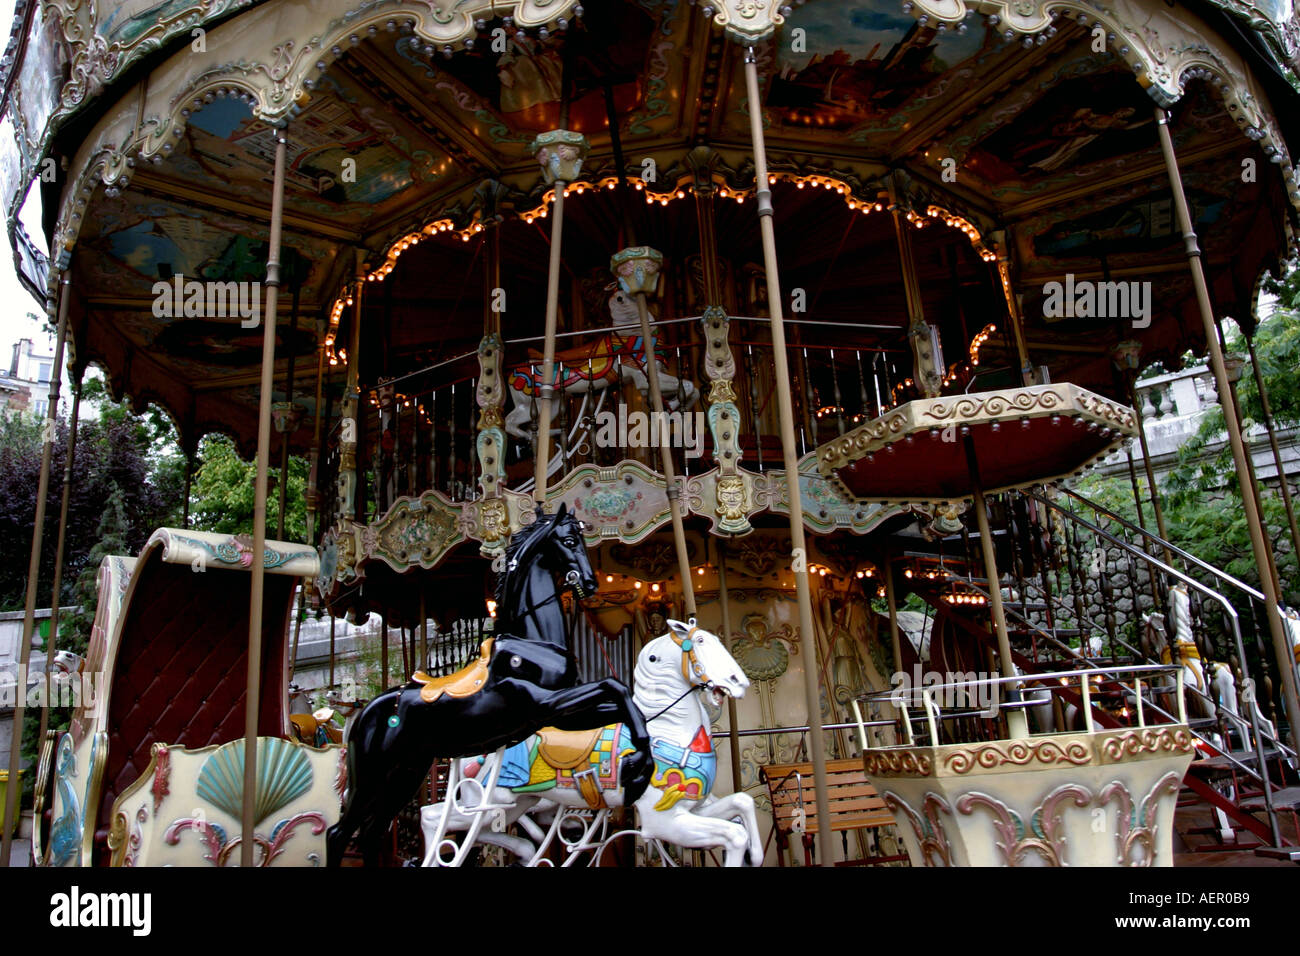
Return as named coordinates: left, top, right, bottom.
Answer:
left=633, top=620, right=749, bottom=704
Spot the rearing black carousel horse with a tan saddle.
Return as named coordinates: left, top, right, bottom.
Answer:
left=326, top=505, right=654, bottom=866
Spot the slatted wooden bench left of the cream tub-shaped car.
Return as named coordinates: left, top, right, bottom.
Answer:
left=761, top=757, right=907, bottom=866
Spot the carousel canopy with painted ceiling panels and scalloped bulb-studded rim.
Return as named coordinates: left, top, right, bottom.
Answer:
left=4, top=0, right=1300, bottom=453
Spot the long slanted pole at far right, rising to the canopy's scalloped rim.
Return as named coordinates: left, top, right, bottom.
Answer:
left=1156, top=107, right=1300, bottom=749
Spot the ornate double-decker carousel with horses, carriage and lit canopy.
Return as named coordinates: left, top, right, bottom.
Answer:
left=0, top=0, right=1300, bottom=866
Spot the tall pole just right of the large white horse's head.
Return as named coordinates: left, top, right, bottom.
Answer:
left=745, top=47, right=835, bottom=866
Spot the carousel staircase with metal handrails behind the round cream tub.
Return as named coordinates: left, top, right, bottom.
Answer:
left=901, top=489, right=1300, bottom=862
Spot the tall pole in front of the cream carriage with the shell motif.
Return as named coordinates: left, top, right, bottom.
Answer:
left=239, top=129, right=289, bottom=868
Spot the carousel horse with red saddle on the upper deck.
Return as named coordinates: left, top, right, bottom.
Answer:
left=506, top=290, right=699, bottom=441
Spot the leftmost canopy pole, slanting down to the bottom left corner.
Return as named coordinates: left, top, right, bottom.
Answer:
left=0, top=269, right=72, bottom=866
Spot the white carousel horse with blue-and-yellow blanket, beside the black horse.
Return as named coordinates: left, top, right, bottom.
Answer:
left=421, top=620, right=763, bottom=866
